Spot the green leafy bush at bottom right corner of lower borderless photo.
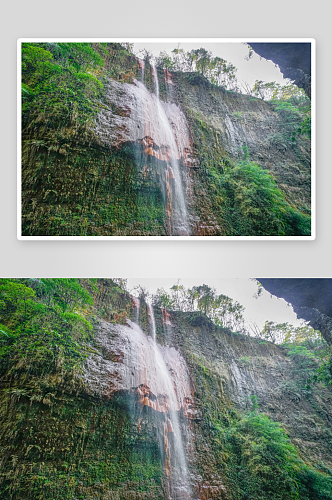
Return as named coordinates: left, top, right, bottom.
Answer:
left=223, top=410, right=332, bottom=500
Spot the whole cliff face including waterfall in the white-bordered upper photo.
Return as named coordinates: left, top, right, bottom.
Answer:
left=22, top=44, right=310, bottom=236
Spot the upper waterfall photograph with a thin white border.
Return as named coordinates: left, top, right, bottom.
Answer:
left=17, top=38, right=315, bottom=240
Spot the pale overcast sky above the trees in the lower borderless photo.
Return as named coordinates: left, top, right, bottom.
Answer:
left=128, top=278, right=302, bottom=329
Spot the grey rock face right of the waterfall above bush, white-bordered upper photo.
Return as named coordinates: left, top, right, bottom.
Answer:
left=174, top=74, right=311, bottom=218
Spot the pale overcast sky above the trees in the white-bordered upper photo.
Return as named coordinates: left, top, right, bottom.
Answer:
left=134, top=41, right=287, bottom=88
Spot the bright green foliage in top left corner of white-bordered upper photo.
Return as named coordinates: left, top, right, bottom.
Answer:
left=22, top=43, right=104, bottom=129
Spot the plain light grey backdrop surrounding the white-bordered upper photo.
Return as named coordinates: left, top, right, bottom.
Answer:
left=0, top=0, right=332, bottom=278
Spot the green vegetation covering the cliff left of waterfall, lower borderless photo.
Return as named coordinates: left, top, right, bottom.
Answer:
left=0, top=278, right=163, bottom=500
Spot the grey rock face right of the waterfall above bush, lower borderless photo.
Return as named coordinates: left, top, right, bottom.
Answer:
left=167, top=317, right=332, bottom=472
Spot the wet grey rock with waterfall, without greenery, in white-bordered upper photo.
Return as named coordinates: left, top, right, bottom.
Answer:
left=95, top=66, right=311, bottom=236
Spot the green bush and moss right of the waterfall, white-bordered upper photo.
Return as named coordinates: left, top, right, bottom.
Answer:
left=184, top=112, right=311, bottom=236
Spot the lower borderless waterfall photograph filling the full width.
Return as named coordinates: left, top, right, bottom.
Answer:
left=0, top=278, right=332, bottom=500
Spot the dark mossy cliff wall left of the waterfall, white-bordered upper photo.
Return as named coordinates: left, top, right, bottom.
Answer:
left=22, top=142, right=166, bottom=236
